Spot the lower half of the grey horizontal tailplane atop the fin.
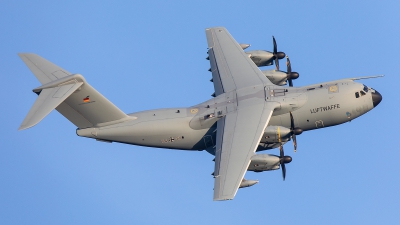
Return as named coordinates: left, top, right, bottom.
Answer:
left=18, top=82, right=83, bottom=130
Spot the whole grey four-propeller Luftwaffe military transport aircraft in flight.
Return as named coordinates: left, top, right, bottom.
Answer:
left=19, top=27, right=382, bottom=200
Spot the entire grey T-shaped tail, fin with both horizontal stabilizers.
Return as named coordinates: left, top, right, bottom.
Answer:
left=19, top=53, right=130, bottom=130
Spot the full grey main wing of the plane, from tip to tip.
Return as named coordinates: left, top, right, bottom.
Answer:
left=206, top=27, right=279, bottom=200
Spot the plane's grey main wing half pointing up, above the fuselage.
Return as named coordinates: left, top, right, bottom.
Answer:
left=206, top=27, right=272, bottom=96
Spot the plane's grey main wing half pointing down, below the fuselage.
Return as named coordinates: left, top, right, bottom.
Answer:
left=214, top=99, right=279, bottom=201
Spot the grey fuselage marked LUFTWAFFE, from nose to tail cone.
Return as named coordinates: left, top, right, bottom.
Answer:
left=77, top=80, right=379, bottom=154
